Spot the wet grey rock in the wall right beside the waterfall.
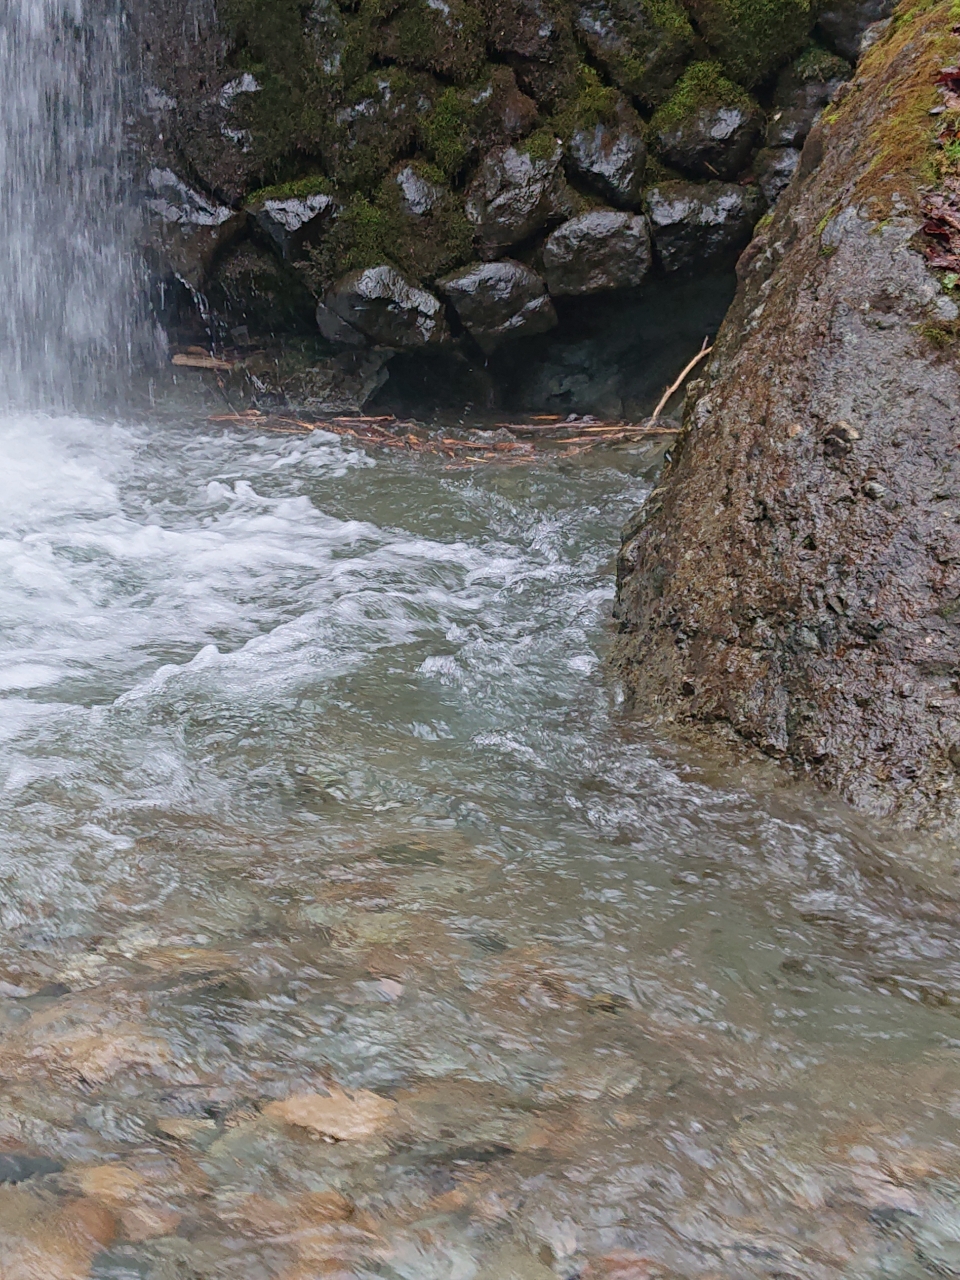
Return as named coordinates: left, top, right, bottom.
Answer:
left=143, top=168, right=247, bottom=292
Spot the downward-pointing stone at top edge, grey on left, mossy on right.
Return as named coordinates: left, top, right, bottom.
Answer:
left=576, top=0, right=695, bottom=105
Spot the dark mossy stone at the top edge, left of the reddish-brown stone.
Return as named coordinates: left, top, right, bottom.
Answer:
left=375, top=0, right=486, bottom=82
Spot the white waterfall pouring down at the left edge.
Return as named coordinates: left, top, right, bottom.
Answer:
left=0, top=0, right=138, bottom=408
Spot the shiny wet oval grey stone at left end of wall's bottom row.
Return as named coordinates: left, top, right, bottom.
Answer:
left=324, top=266, right=449, bottom=349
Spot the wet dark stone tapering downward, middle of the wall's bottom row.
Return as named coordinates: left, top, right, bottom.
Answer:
left=436, top=259, right=557, bottom=355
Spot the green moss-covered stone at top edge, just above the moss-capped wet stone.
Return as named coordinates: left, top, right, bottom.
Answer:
left=689, top=0, right=815, bottom=88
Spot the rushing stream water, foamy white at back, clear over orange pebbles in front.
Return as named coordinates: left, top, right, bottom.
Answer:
left=0, top=413, right=960, bottom=1280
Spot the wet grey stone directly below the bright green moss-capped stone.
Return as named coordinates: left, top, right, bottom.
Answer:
left=646, top=182, right=763, bottom=271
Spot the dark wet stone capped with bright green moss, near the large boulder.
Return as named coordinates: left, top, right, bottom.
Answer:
left=650, top=63, right=764, bottom=178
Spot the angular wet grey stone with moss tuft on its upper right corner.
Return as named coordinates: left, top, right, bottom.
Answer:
left=466, top=143, right=572, bottom=256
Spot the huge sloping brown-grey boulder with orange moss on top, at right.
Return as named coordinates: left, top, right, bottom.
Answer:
left=617, top=4, right=960, bottom=823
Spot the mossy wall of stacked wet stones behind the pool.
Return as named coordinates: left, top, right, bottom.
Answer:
left=132, top=0, right=884, bottom=404
